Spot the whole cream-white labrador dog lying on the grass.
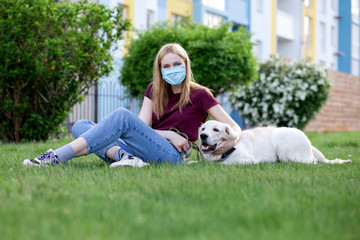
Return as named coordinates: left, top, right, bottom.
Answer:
left=199, top=120, right=351, bottom=164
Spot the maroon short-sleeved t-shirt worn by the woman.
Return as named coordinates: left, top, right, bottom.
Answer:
left=144, top=84, right=219, bottom=142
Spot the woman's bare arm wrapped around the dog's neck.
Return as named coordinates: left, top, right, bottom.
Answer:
left=208, top=104, right=241, bottom=154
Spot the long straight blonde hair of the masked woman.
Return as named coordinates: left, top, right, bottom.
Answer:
left=151, top=43, right=211, bottom=119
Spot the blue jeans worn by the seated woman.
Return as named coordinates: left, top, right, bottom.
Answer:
left=72, top=108, right=182, bottom=164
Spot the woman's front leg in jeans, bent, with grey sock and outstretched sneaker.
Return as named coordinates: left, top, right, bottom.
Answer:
left=23, top=108, right=182, bottom=166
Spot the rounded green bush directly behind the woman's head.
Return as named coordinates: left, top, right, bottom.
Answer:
left=120, top=20, right=256, bottom=98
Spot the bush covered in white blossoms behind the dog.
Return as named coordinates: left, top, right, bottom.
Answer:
left=230, top=57, right=330, bottom=129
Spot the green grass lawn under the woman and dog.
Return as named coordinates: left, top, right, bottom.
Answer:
left=0, top=132, right=360, bottom=240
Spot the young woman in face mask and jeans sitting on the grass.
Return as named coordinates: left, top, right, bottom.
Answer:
left=23, top=43, right=241, bottom=167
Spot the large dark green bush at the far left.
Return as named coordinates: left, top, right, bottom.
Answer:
left=0, top=0, right=129, bottom=142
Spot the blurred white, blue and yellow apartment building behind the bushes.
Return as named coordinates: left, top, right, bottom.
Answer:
left=69, top=0, right=360, bottom=128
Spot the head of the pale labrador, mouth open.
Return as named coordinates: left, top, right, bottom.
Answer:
left=199, top=120, right=238, bottom=161
